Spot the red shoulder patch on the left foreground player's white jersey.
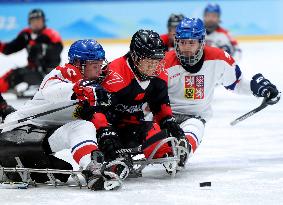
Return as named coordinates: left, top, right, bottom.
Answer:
left=53, top=64, right=82, bottom=83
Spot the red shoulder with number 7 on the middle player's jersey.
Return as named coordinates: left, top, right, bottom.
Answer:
left=102, top=55, right=134, bottom=92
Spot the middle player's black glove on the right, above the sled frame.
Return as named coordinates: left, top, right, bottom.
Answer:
left=160, top=117, right=185, bottom=140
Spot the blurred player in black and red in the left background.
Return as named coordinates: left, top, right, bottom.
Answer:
left=0, top=9, right=63, bottom=96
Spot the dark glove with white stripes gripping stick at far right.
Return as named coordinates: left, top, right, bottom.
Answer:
left=251, top=73, right=279, bottom=100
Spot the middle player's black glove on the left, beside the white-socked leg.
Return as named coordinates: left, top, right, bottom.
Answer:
left=96, top=127, right=122, bottom=161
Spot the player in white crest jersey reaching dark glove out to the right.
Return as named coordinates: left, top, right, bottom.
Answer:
left=165, top=18, right=279, bottom=160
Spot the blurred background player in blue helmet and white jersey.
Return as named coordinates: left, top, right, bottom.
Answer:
left=203, top=4, right=242, bottom=62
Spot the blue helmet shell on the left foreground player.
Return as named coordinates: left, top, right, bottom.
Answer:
left=68, top=39, right=105, bottom=63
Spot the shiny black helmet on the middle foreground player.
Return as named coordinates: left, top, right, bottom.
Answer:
left=130, top=29, right=165, bottom=60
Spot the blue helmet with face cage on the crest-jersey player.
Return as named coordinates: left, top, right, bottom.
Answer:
left=175, top=18, right=206, bottom=66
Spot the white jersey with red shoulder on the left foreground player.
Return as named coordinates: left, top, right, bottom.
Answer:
left=3, top=64, right=82, bottom=131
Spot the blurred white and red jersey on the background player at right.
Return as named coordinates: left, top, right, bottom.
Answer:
left=205, top=27, right=242, bottom=62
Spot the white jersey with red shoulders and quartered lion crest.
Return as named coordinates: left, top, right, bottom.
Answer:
left=165, top=46, right=252, bottom=120
